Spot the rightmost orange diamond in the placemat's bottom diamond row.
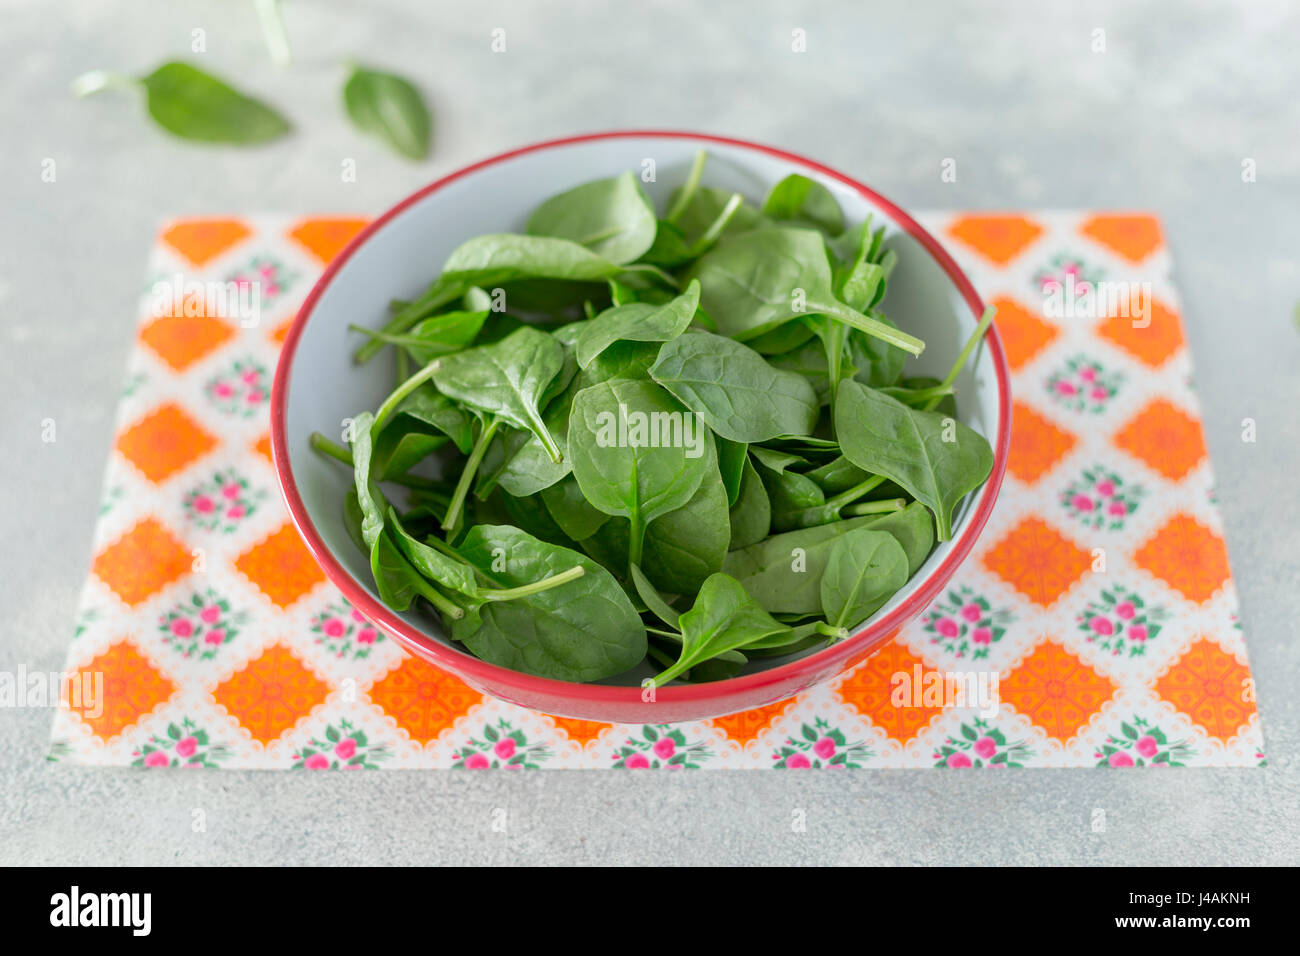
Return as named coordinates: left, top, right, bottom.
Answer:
left=1156, top=637, right=1255, bottom=741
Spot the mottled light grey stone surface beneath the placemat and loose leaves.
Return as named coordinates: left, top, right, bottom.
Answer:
left=0, top=0, right=1300, bottom=864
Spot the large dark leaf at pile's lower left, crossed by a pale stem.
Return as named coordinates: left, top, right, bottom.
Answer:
left=451, top=524, right=646, bottom=680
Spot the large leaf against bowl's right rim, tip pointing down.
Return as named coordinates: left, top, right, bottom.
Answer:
left=835, top=380, right=993, bottom=541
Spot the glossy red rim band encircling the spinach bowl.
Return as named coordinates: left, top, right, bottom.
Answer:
left=270, top=130, right=1011, bottom=706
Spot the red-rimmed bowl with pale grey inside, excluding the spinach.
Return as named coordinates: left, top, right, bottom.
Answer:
left=272, top=131, right=1011, bottom=723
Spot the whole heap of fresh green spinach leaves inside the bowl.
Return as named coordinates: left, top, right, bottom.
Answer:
left=313, top=153, right=993, bottom=683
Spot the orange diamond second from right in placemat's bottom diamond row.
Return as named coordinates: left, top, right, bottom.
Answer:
left=998, top=640, right=1115, bottom=743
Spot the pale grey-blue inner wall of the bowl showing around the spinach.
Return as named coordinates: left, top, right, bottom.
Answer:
left=280, top=134, right=1000, bottom=683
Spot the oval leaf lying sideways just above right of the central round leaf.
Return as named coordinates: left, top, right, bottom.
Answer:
left=650, top=332, right=819, bottom=442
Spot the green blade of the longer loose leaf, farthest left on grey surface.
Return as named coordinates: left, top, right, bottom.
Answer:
left=126, top=61, right=290, bottom=146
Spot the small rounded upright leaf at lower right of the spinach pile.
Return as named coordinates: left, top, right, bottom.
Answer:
left=822, top=528, right=909, bottom=628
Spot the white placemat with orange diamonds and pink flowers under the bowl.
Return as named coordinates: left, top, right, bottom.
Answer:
left=51, top=212, right=1264, bottom=770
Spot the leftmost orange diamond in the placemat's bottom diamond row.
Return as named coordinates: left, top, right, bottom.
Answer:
left=64, top=640, right=177, bottom=740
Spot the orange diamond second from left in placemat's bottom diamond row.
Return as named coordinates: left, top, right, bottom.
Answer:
left=212, top=644, right=330, bottom=745
